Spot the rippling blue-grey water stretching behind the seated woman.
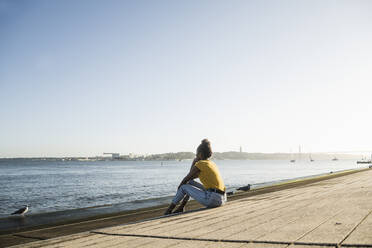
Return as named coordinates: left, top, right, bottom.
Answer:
left=0, top=160, right=361, bottom=218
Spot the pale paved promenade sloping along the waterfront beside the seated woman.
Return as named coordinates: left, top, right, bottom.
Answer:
left=10, top=169, right=372, bottom=248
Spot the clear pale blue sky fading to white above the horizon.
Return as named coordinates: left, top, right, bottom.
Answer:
left=0, top=0, right=372, bottom=157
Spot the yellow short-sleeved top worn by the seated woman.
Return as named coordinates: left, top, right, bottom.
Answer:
left=195, top=160, right=226, bottom=191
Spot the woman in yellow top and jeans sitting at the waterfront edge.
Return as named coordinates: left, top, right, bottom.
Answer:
left=164, top=139, right=226, bottom=215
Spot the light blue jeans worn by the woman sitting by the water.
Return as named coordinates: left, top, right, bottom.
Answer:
left=172, top=180, right=226, bottom=208
